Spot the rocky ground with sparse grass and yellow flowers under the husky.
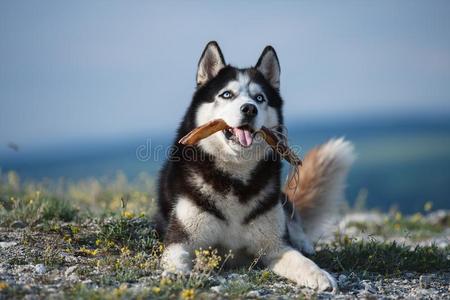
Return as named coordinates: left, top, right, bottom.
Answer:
left=0, top=211, right=450, bottom=299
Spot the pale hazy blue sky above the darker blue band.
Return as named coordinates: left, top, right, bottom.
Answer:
left=0, top=0, right=450, bottom=147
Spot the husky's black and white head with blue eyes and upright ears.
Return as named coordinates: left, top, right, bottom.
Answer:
left=188, top=42, right=283, bottom=160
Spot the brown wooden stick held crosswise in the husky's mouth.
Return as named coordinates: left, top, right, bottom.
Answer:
left=179, top=119, right=302, bottom=166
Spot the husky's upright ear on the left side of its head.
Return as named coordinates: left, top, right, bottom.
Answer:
left=197, top=41, right=225, bottom=86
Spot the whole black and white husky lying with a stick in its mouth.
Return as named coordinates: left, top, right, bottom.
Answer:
left=158, top=42, right=353, bottom=290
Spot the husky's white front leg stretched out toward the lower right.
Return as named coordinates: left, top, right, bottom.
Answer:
left=263, top=246, right=337, bottom=291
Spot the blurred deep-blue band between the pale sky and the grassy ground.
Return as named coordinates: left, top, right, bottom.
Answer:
left=0, top=115, right=450, bottom=213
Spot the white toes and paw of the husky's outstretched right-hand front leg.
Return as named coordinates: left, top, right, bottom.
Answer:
left=296, top=267, right=337, bottom=292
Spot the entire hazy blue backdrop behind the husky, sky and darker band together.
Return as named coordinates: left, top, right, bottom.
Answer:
left=0, top=1, right=450, bottom=212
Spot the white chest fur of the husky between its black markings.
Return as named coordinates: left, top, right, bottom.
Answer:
left=175, top=174, right=285, bottom=252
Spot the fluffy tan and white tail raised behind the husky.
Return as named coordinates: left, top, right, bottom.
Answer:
left=285, top=138, right=355, bottom=239
